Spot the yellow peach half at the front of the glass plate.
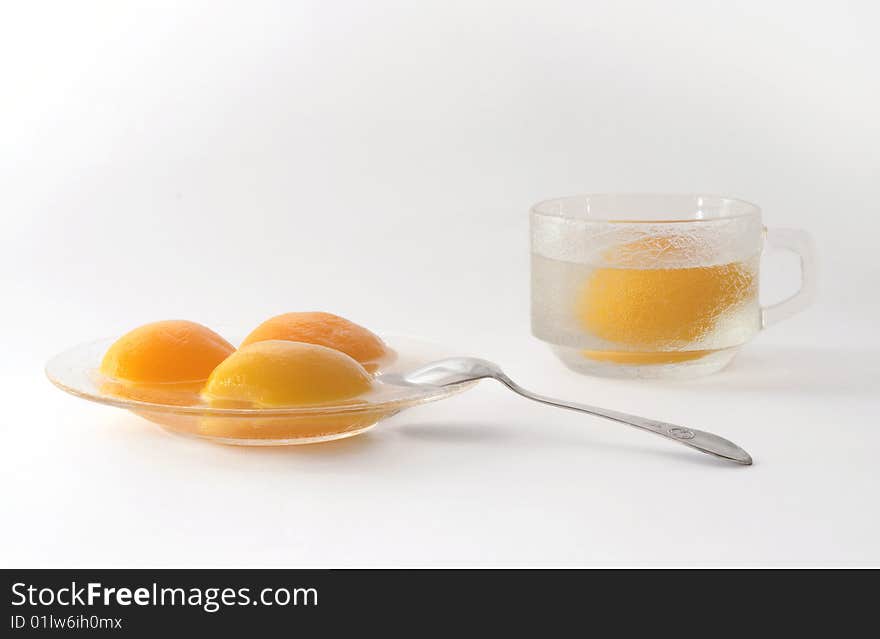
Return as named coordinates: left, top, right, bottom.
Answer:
left=202, top=340, right=373, bottom=408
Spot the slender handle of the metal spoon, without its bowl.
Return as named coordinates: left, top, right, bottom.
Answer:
left=496, top=375, right=752, bottom=466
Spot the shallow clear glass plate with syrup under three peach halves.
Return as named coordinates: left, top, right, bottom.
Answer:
left=46, top=335, right=473, bottom=446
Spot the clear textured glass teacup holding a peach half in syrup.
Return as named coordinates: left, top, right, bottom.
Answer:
left=531, top=194, right=816, bottom=378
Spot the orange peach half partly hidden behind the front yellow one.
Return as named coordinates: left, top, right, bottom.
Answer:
left=241, top=312, right=391, bottom=372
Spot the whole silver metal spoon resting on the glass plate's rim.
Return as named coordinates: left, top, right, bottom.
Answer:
left=379, top=357, right=752, bottom=466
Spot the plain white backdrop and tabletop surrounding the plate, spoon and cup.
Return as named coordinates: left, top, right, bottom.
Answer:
left=0, top=0, right=880, bottom=566
